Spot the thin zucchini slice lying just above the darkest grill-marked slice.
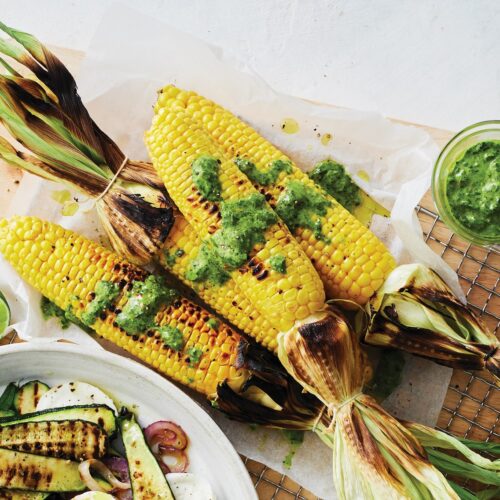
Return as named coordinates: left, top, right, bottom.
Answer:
left=0, top=405, right=116, bottom=437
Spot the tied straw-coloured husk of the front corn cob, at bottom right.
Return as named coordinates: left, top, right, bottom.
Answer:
left=278, top=310, right=498, bottom=499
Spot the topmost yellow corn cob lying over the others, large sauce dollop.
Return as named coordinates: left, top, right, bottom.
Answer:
left=146, top=103, right=325, bottom=331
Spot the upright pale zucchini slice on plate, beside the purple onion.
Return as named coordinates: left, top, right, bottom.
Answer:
left=118, top=412, right=174, bottom=500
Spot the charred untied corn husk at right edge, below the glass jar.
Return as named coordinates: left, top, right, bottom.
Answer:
left=365, top=264, right=500, bottom=379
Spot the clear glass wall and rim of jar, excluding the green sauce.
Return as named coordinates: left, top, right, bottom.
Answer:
left=432, top=120, right=500, bottom=247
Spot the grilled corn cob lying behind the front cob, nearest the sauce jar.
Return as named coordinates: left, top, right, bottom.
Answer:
left=160, top=86, right=395, bottom=304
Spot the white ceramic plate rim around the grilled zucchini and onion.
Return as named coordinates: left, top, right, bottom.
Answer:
left=0, top=343, right=257, bottom=500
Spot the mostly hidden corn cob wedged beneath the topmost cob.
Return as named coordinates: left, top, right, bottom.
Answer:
left=160, top=212, right=278, bottom=351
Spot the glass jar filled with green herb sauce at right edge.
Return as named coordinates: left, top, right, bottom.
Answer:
left=432, top=120, right=500, bottom=247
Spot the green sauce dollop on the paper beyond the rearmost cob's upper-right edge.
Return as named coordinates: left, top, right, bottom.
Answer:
left=309, top=159, right=361, bottom=212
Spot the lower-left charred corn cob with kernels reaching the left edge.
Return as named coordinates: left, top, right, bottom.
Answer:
left=0, top=217, right=249, bottom=395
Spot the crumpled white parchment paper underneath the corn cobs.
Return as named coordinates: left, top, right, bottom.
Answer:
left=0, top=4, right=463, bottom=498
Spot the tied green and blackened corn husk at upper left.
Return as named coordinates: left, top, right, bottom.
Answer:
left=0, top=23, right=173, bottom=264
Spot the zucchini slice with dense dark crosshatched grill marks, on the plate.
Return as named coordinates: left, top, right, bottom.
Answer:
left=0, top=420, right=107, bottom=461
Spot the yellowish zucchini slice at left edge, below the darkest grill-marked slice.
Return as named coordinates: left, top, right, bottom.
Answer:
left=0, top=448, right=86, bottom=493
